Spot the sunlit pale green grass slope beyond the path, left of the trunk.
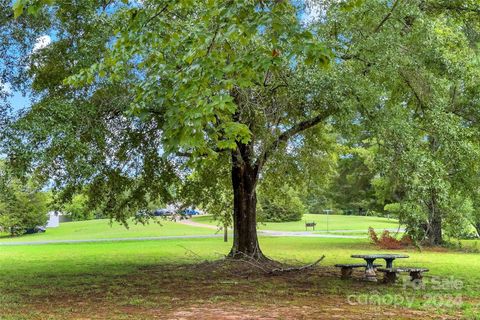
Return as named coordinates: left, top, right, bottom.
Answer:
left=0, top=219, right=215, bottom=242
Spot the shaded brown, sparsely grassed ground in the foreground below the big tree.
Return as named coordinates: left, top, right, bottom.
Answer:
left=0, top=261, right=466, bottom=320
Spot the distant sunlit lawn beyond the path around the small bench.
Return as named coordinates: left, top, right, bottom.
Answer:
left=193, top=214, right=398, bottom=233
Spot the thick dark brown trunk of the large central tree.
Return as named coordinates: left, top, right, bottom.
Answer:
left=229, top=145, right=265, bottom=260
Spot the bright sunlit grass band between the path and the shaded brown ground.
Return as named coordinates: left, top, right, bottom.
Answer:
left=0, top=237, right=480, bottom=291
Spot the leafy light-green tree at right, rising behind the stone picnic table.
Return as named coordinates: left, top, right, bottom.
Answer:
left=321, top=0, right=479, bottom=244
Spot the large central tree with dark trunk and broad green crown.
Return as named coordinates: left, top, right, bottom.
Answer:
left=11, top=1, right=342, bottom=258
